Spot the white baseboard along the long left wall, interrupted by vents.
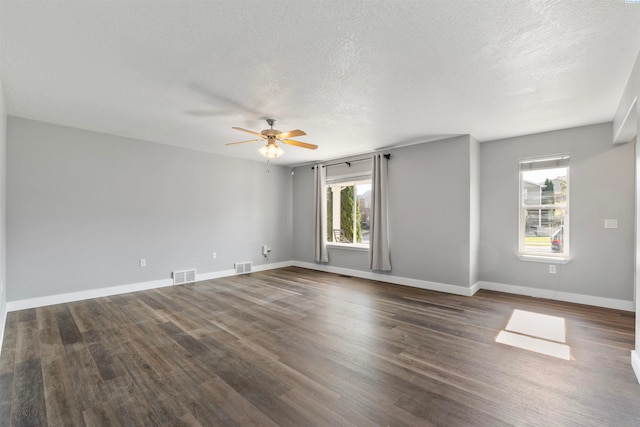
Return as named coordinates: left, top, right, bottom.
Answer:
left=5, top=261, right=291, bottom=310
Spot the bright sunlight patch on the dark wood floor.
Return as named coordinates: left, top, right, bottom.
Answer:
left=496, top=310, right=571, bottom=360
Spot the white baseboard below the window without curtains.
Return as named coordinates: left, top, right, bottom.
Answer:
left=478, top=282, right=635, bottom=311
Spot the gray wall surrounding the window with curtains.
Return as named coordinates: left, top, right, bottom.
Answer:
left=293, top=135, right=478, bottom=287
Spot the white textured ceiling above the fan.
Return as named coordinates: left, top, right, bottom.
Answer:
left=0, top=0, right=640, bottom=165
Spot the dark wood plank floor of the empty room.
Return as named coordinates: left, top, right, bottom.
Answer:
left=0, top=267, right=640, bottom=426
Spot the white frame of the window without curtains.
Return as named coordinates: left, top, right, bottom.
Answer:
left=517, top=154, right=571, bottom=264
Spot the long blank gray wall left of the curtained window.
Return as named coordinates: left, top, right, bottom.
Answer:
left=7, top=117, right=292, bottom=301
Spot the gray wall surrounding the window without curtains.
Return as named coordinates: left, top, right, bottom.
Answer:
left=480, top=123, right=634, bottom=301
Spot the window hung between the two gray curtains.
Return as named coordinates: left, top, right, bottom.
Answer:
left=327, top=177, right=371, bottom=245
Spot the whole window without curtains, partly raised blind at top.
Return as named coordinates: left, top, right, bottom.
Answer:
left=518, top=155, right=569, bottom=259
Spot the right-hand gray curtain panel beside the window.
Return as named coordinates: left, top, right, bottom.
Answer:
left=369, top=154, right=391, bottom=271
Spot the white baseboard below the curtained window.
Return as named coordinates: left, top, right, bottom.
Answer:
left=291, top=261, right=479, bottom=296
